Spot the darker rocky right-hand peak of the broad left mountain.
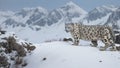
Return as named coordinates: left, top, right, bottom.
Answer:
left=26, top=7, right=48, bottom=26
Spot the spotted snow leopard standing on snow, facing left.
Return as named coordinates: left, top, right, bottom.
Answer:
left=65, top=23, right=115, bottom=50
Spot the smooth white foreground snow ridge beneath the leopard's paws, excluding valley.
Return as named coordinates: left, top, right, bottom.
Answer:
left=24, top=41, right=120, bottom=68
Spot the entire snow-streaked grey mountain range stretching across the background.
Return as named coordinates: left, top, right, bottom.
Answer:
left=0, top=2, right=120, bottom=29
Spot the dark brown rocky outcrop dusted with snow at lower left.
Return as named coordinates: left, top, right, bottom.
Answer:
left=0, top=31, right=36, bottom=68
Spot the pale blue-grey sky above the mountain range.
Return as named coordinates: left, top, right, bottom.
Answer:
left=0, top=0, right=120, bottom=11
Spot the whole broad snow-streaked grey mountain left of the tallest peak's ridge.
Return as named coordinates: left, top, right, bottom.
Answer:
left=4, top=7, right=48, bottom=27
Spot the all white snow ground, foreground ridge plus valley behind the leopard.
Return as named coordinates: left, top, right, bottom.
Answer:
left=2, top=22, right=120, bottom=68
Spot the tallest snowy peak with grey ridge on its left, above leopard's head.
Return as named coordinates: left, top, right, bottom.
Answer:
left=47, top=2, right=87, bottom=25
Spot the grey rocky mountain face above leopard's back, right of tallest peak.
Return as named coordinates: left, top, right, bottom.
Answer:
left=86, top=5, right=118, bottom=22
